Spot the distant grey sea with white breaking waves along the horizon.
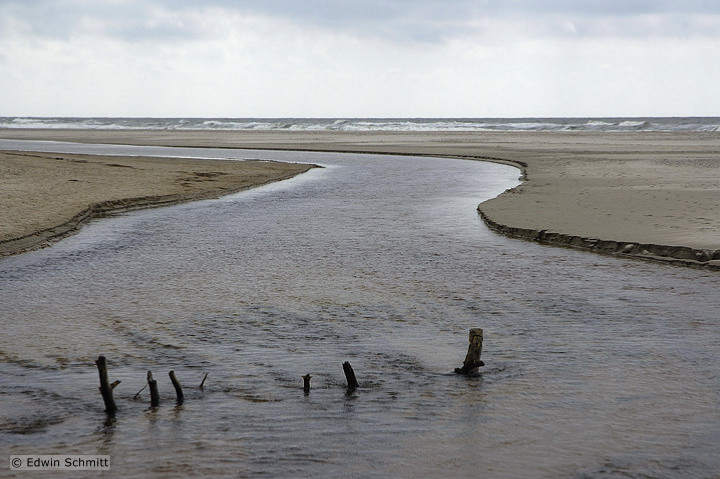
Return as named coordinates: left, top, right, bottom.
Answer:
left=0, top=117, right=720, bottom=132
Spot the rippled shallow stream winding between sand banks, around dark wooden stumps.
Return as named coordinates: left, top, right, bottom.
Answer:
left=0, top=144, right=720, bottom=478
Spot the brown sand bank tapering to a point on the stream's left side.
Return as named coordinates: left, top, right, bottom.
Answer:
left=0, top=151, right=312, bottom=256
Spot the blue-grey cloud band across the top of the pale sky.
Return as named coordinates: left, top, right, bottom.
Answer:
left=5, top=0, right=720, bottom=42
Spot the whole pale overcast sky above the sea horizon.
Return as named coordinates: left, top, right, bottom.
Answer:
left=0, top=0, right=720, bottom=117
